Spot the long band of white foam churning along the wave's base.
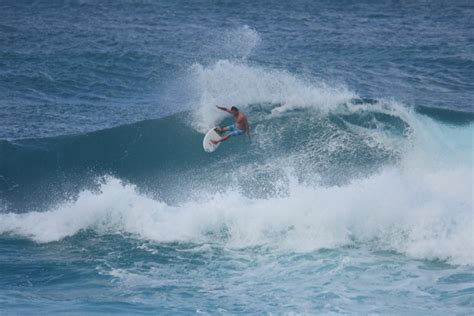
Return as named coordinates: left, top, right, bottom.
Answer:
left=0, top=113, right=474, bottom=264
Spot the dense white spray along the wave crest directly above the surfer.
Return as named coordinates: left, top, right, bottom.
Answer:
left=189, top=60, right=356, bottom=132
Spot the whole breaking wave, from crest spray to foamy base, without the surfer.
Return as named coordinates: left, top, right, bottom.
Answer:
left=0, top=60, right=474, bottom=264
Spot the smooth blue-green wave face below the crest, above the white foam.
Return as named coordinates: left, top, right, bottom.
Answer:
left=0, top=100, right=410, bottom=212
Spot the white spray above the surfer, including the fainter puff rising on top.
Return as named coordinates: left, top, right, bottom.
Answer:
left=185, top=26, right=356, bottom=132
